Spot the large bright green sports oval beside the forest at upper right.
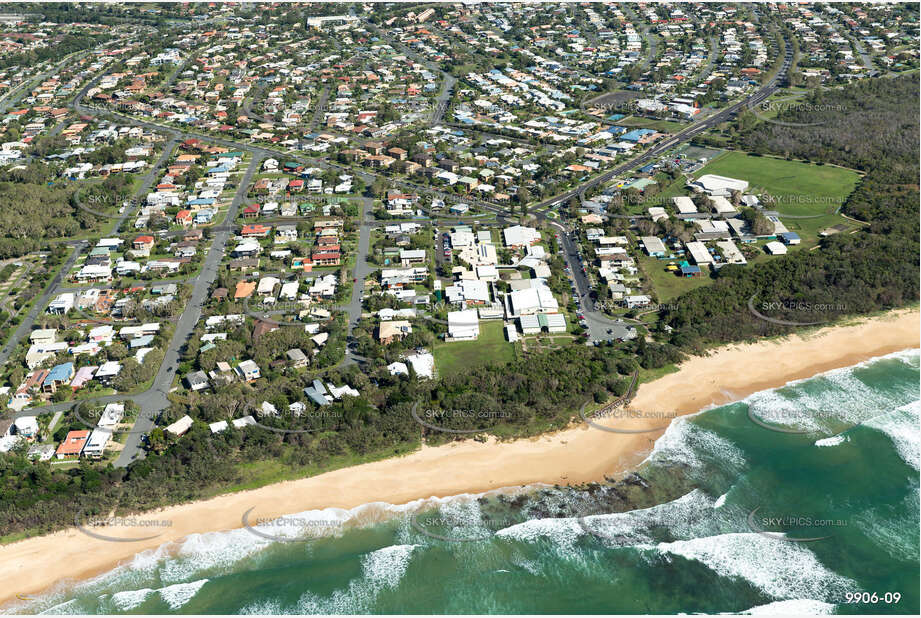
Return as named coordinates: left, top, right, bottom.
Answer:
left=694, top=152, right=860, bottom=215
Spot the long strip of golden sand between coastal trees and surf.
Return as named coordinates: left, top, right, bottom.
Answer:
left=0, top=310, right=921, bottom=602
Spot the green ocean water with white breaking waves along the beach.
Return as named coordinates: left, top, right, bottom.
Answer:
left=4, top=350, right=921, bottom=614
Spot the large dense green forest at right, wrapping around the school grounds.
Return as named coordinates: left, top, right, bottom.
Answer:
left=662, top=76, right=919, bottom=352
